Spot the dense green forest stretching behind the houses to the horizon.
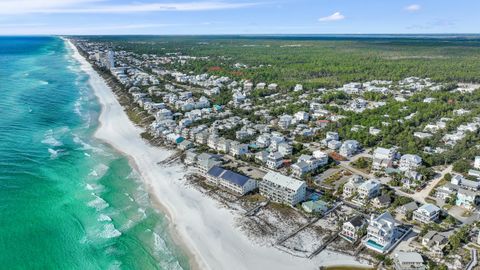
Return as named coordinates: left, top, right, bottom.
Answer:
left=79, top=36, right=480, bottom=89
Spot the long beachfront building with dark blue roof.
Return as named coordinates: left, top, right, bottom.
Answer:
left=207, top=166, right=257, bottom=195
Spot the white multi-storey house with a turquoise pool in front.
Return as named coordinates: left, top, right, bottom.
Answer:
left=363, top=212, right=402, bottom=253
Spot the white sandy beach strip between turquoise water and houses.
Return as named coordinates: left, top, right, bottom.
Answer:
left=68, top=38, right=370, bottom=270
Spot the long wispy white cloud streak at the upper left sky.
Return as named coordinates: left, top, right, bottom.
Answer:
left=0, top=0, right=259, bottom=14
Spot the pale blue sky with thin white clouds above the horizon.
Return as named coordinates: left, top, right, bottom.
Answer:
left=0, top=0, right=480, bottom=35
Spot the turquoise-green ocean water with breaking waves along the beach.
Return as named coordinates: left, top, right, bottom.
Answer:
left=0, top=37, right=189, bottom=269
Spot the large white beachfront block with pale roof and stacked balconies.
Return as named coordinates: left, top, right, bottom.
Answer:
left=259, top=171, right=307, bottom=206
